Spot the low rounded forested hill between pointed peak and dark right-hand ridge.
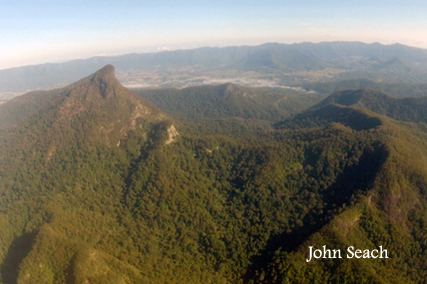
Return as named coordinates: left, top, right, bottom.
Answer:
left=136, top=84, right=320, bottom=121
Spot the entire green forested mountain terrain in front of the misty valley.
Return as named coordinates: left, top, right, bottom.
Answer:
left=0, top=66, right=427, bottom=283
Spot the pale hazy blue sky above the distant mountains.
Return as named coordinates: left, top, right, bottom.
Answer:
left=0, top=0, right=427, bottom=68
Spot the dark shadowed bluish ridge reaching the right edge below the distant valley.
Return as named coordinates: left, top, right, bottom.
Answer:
left=274, top=89, right=427, bottom=130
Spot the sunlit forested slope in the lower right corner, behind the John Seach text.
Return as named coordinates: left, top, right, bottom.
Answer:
left=248, top=122, right=427, bottom=283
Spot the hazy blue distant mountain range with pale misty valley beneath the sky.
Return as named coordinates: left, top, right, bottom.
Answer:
left=0, top=42, right=427, bottom=93
